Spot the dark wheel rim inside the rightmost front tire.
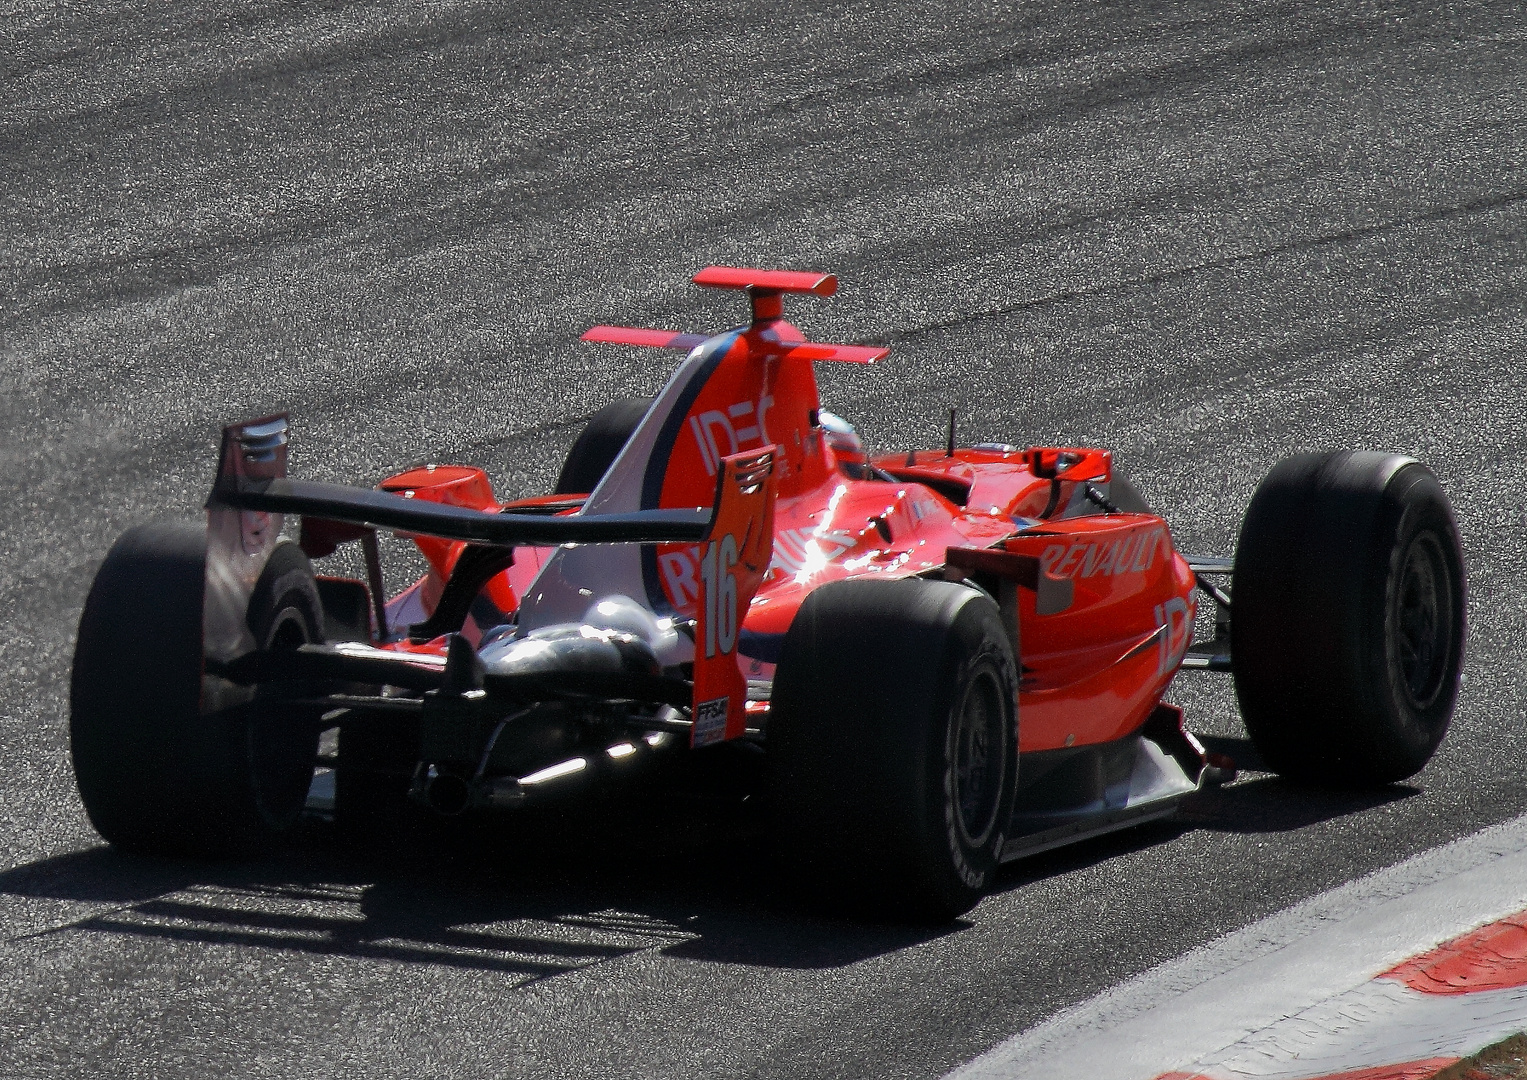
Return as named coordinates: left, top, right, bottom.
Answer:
left=1388, top=533, right=1457, bottom=709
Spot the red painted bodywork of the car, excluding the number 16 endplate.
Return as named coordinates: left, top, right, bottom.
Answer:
left=363, top=267, right=1196, bottom=752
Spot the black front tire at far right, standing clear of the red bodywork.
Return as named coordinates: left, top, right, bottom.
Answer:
left=1231, top=451, right=1464, bottom=785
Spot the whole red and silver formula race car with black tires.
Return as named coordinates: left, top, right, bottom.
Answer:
left=70, top=267, right=1464, bottom=920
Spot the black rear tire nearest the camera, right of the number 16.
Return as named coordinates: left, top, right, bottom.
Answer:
left=768, top=579, right=1019, bottom=921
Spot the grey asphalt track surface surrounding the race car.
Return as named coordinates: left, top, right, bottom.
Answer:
left=0, top=0, right=1527, bottom=1077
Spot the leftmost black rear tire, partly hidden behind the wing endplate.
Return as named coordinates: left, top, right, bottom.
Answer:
left=69, top=522, right=324, bottom=855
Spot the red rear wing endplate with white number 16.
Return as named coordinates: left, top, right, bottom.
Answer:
left=690, top=446, right=774, bottom=747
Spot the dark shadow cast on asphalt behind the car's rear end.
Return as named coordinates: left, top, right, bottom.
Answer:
left=0, top=808, right=964, bottom=985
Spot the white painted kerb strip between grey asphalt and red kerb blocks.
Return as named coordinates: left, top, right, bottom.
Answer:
left=950, top=816, right=1527, bottom=1080
